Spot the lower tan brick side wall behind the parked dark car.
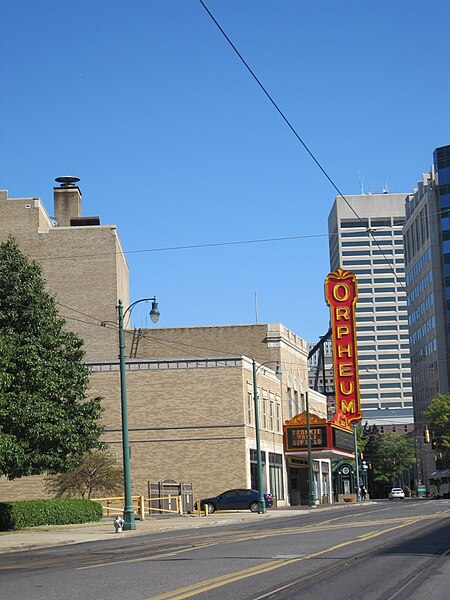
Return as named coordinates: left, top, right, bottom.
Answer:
left=90, top=358, right=282, bottom=497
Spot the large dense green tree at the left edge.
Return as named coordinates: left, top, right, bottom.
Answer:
left=0, top=238, right=103, bottom=479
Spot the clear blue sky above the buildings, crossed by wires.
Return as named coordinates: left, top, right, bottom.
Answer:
left=0, top=0, right=450, bottom=341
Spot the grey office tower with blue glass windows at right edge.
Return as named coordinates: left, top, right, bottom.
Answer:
left=404, top=146, right=450, bottom=427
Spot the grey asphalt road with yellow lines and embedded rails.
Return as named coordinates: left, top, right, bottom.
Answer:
left=0, top=500, right=450, bottom=600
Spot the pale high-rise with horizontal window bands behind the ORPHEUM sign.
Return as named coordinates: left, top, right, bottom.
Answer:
left=328, top=193, right=413, bottom=433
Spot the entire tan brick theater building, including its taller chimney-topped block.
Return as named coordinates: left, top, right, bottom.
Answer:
left=0, top=183, right=331, bottom=504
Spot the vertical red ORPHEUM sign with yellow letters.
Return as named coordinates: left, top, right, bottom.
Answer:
left=325, top=269, right=362, bottom=429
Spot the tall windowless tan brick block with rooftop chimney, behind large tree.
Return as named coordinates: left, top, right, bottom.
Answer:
left=0, top=185, right=129, bottom=359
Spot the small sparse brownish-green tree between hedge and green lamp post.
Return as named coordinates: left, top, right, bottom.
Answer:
left=45, top=450, right=123, bottom=499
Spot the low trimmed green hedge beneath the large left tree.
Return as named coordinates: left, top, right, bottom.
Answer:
left=0, top=498, right=103, bottom=531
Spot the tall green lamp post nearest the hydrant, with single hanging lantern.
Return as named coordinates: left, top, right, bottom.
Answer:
left=117, top=298, right=159, bottom=531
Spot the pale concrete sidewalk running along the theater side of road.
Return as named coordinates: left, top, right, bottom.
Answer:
left=0, top=504, right=348, bottom=554
